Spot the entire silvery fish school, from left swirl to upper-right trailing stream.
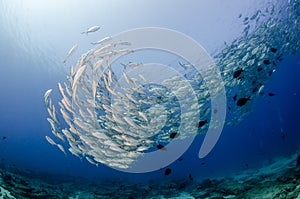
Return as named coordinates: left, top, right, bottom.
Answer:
left=44, top=0, right=300, bottom=169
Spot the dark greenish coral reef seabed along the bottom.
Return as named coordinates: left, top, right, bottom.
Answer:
left=0, top=155, right=300, bottom=199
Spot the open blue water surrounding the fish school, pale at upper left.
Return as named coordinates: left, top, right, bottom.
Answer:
left=0, top=0, right=300, bottom=183
